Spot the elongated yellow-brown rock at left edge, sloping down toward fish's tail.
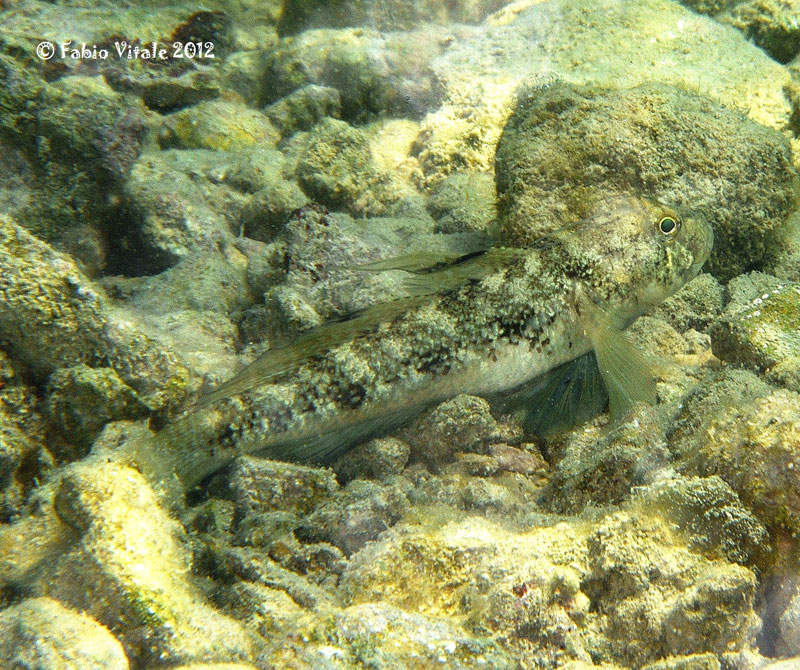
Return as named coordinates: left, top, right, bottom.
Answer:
left=0, top=217, right=189, bottom=408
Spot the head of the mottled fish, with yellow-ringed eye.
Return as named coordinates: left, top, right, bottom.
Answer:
left=555, top=197, right=714, bottom=322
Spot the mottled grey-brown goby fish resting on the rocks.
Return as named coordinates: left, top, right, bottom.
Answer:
left=136, top=198, right=712, bottom=489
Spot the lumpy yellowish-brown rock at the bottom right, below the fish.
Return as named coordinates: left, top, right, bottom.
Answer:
left=583, top=512, right=760, bottom=665
